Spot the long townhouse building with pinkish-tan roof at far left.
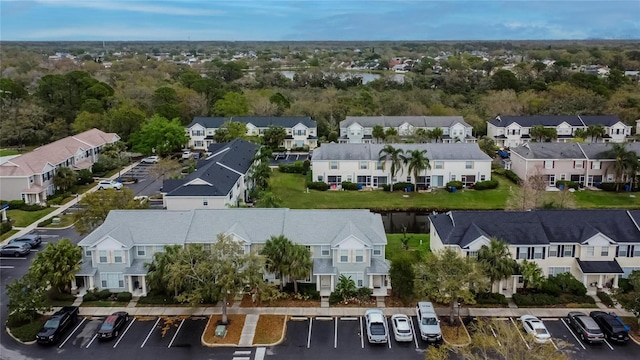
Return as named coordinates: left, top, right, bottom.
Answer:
left=0, top=129, right=120, bottom=204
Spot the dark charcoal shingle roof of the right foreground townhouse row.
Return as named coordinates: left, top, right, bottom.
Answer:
left=429, top=210, right=640, bottom=248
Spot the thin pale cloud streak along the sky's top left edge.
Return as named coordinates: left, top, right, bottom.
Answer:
left=37, top=0, right=224, bottom=16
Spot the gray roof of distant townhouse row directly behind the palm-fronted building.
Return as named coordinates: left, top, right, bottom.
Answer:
left=340, top=116, right=471, bottom=128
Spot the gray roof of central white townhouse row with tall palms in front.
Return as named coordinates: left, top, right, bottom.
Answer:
left=312, top=143, right=491, bottom=161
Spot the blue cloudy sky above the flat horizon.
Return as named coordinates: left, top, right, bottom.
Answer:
left=0, top=0, right=640, bottom=41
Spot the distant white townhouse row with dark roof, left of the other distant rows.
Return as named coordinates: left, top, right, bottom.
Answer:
left=187, top=116, right=318, bottom=150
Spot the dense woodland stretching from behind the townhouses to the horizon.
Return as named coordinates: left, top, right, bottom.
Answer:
left=0, top=41, right=640, bottom=147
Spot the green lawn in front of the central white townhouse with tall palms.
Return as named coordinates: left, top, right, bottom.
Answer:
left=271, top=170, right=513, bottom=210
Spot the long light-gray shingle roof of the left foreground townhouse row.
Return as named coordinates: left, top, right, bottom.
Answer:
left=75, top=209, right=387, bottom=247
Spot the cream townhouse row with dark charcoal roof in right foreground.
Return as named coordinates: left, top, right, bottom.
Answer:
left=429, top=210, right=640, bottom=297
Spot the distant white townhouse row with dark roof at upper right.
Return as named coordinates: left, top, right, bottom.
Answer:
left=487, top=115, right=631, bottom=148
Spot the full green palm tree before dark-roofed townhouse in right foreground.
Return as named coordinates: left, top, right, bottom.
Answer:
left=478, top=238, right=516, bottom=292
